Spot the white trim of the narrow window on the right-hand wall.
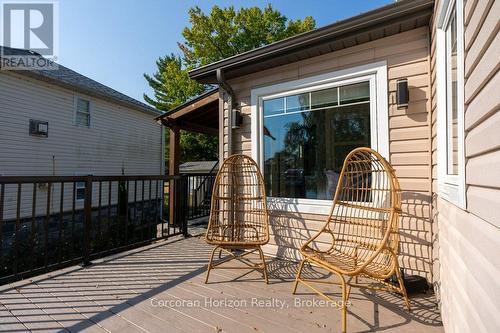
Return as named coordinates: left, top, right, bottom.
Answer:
left=436, top=0, right=467, bottom=209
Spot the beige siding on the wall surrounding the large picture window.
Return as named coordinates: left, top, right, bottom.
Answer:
left=224, top=27, right=433, bottom=280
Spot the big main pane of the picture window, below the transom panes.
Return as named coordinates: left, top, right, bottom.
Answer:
left=264, top=103, right=370, bottom=199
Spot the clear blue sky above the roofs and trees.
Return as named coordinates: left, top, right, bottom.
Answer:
left=59, top=0, right=393, bottom=101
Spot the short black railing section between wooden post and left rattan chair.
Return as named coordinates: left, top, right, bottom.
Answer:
left=185, top=173, right=216, bottom=220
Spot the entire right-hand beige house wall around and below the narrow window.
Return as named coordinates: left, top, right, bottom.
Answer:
left=431, top=0, right=500, bottom=332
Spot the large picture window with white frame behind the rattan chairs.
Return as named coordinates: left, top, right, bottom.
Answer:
left=251, top=61, right=389, bottom=214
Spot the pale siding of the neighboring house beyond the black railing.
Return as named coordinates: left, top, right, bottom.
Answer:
left=0, top=73, right=163, bottom=219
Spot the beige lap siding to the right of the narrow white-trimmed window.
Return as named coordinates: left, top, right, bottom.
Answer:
left=464, top=1, right=500, bottom=228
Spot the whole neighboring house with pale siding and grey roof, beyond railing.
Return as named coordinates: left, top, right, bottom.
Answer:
left=0, top=47, right=164, bottom=219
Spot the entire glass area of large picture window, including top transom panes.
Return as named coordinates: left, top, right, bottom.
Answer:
left=263, top=81, right=371, bottom=200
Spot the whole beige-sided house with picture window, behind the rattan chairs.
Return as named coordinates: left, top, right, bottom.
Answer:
left=161, top=0, right=500, bottom=332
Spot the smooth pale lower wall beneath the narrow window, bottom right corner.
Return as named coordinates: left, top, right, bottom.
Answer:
left=437, top=199, right=500, bottom=333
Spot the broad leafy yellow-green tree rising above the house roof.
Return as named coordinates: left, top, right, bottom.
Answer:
left=179, top=4, right=315, bottom=68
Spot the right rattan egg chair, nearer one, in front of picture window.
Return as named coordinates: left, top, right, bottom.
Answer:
left=293, top=148, right=410, bottom=332
